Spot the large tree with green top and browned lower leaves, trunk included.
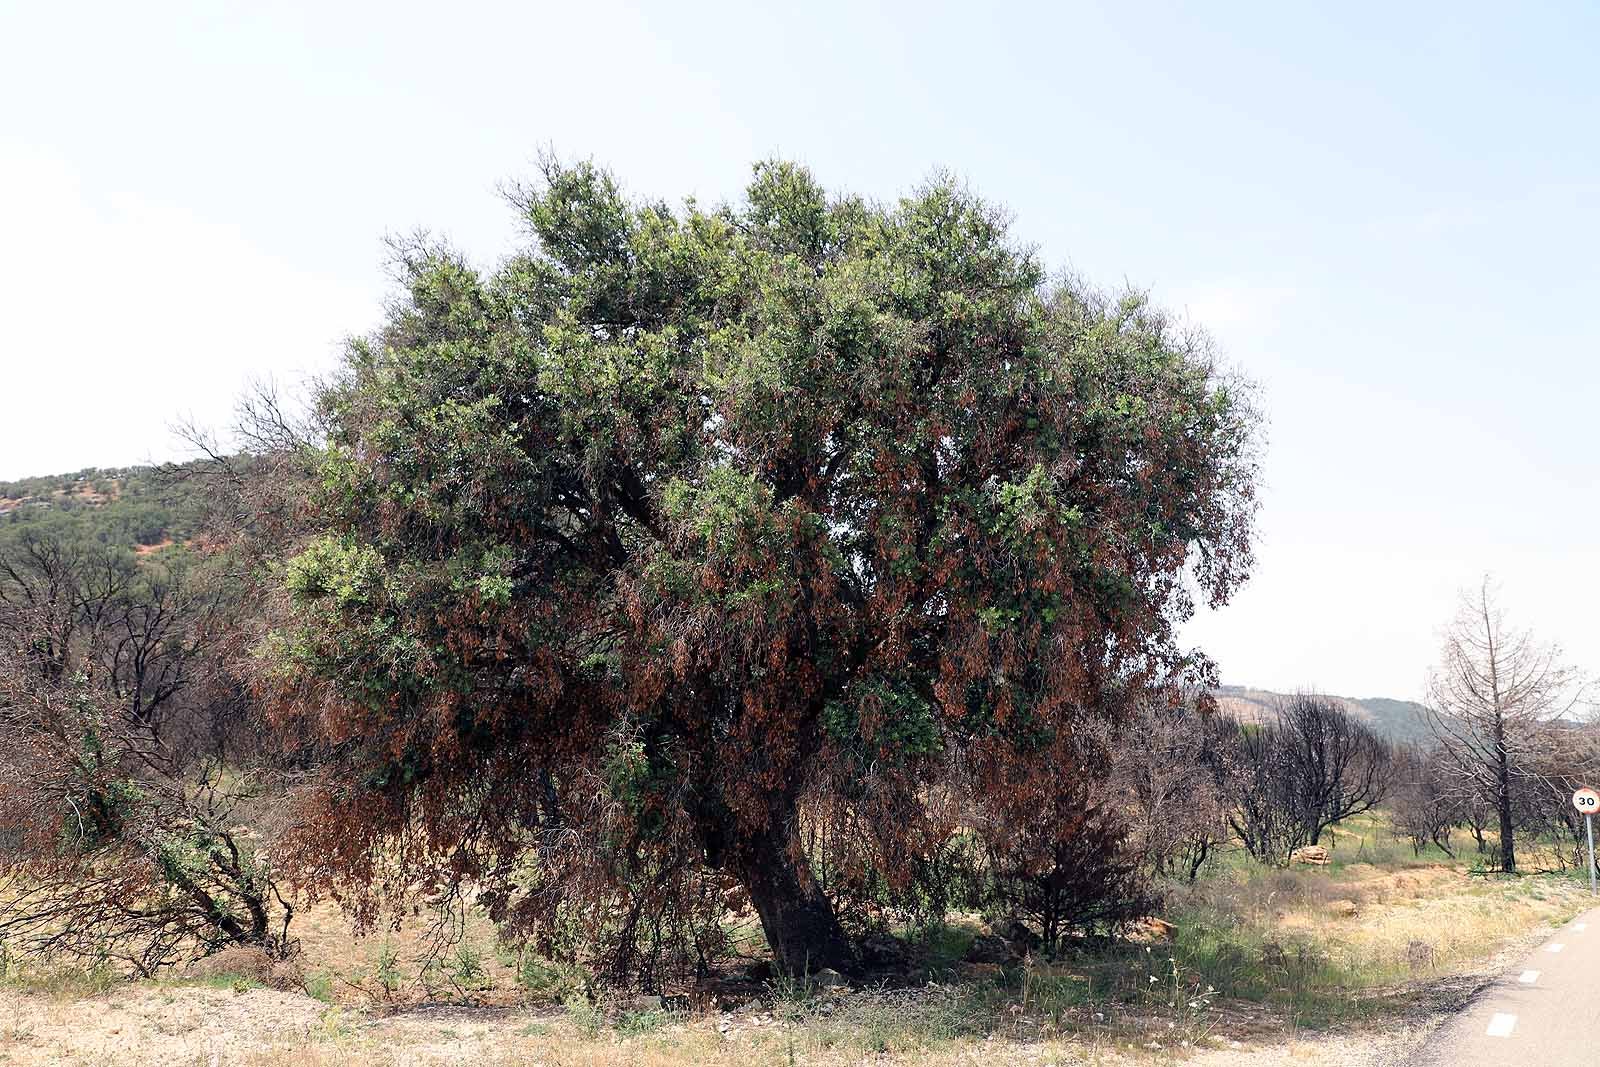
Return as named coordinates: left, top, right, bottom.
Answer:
left=267, top=163, right=1256, bottom=971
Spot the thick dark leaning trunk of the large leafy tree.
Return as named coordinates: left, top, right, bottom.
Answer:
left=736, top=827, right=856, bottom=976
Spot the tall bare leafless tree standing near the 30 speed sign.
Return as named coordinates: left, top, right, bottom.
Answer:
left=1429, top=577, right=1586, bottom=872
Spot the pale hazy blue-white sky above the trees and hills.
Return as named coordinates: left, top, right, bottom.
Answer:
left=0, top=0, right=1600, bottom=697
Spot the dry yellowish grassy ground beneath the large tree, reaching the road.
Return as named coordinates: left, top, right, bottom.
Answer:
left=0, top=819, right=1589, bottom=1067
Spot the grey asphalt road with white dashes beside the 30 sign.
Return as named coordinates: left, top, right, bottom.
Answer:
left=1413, top=909, right=1600, bottom=1067
